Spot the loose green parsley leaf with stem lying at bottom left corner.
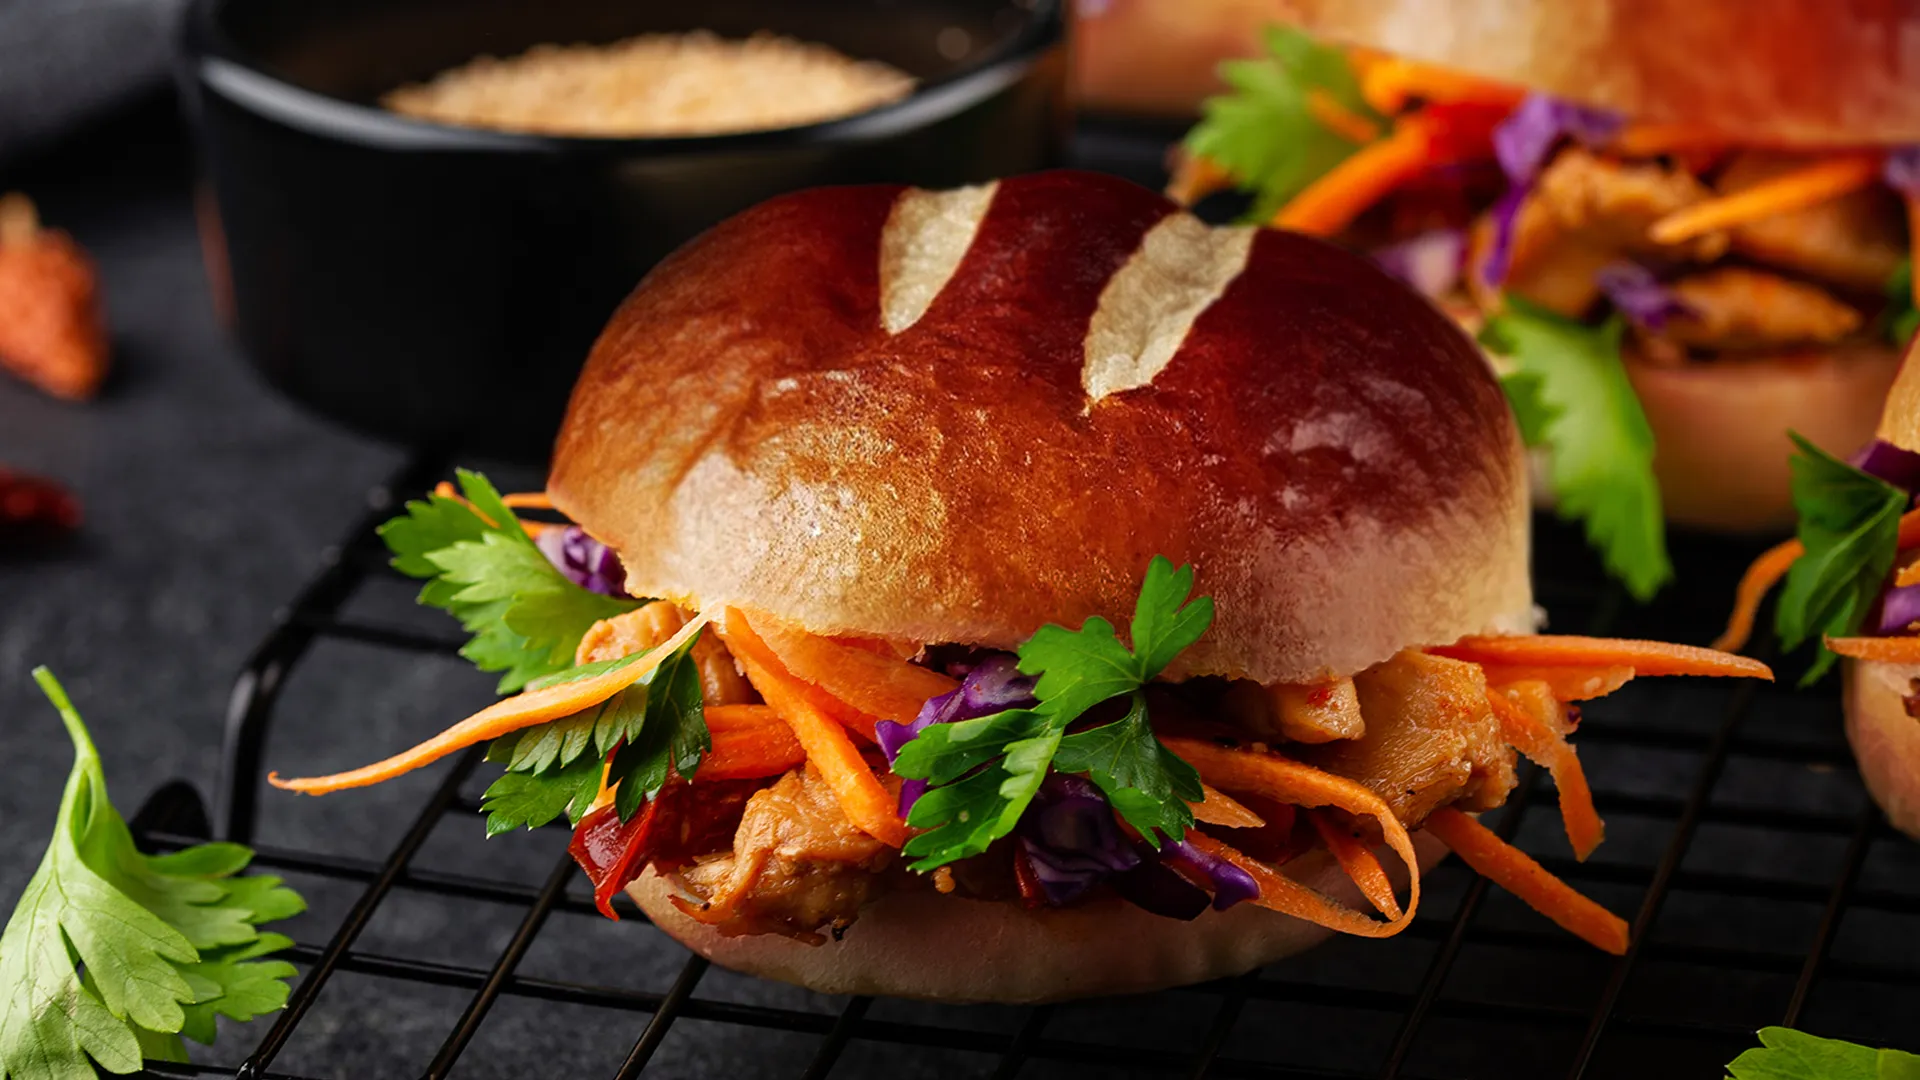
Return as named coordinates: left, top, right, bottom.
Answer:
left=0, top=667, right=305, bottom=1080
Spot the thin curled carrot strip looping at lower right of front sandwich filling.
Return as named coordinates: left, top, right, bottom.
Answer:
left=1162, top=736, right=1421, bottom=938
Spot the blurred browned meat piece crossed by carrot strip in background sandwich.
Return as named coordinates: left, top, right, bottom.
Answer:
left=1715, top=150, right=1907, bottom=292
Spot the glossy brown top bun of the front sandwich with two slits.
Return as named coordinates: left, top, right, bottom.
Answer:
left=549, top=171, right=1532, bottom=682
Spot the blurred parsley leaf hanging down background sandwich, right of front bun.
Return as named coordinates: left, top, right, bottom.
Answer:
left=1480, top=294, right=1672, bottom=601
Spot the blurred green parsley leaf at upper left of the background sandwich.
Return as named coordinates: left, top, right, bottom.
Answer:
left=1187, top=27, right=1388, bottom=221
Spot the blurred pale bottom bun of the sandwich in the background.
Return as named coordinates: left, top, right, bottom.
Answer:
left=1626, top=344, right=1899, bottom=532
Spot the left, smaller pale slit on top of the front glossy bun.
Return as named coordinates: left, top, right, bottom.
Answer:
left=879, top=181, right=1000, bottom=334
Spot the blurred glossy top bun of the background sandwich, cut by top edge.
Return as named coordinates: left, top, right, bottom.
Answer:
left=1277, top=0, right=1920, bottom=144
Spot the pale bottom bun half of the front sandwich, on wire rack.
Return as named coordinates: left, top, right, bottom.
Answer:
left=626, top=832, right=1446, bottom=1003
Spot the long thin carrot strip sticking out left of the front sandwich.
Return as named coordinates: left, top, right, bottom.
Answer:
left=267, top=615, right=707, bottom=796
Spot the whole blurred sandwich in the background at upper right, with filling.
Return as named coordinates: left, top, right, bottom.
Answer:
left=1173, top=0, right=1920, bottom=598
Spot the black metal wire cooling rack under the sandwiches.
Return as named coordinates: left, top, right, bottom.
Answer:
left=120, top=455, right=1920, bottom=1080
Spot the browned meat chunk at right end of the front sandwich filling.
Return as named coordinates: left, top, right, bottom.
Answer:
left=1298, top=650, right=1515, bottom=828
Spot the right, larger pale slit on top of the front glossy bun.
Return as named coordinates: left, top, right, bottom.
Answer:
left=1081, top=213, right=1254, bottom=407
